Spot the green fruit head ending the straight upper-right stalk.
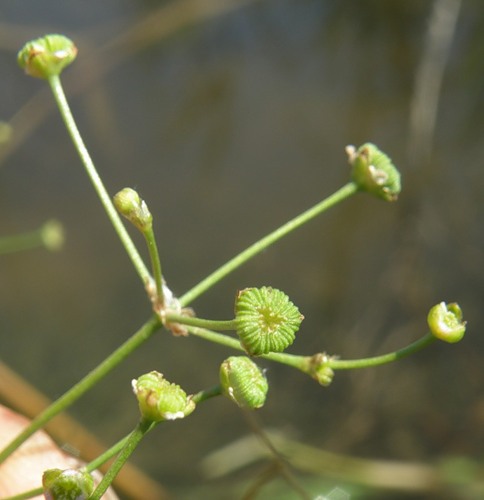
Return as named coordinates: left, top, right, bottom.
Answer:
left=346, top=142, right=401, bottom=201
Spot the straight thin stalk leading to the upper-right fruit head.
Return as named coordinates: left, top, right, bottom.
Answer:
left=180, top=182, right=359, bottom=306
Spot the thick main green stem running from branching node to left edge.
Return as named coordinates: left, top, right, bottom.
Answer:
left=0, top=316, right=161, bottom=463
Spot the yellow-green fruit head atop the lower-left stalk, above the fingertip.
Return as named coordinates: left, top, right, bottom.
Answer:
left=132, top=371, right=195, bottom=422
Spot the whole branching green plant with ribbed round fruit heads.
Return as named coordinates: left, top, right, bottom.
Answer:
left=0, top=35, right=465, bottom=500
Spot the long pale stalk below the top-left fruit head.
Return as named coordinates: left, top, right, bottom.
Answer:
left=48, top=75, right=151, bottom=285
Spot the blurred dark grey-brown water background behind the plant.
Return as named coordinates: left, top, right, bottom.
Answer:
left=0, top=0, right=484, bottom=499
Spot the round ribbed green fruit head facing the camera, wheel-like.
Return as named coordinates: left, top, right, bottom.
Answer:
left=235, top=287, right=304, bottom=356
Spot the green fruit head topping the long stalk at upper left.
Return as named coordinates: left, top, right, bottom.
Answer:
left=17, top=35, right=77, bottom=79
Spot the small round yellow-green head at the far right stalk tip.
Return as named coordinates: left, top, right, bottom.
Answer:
left=427, top=302, right=466, bottom=344
